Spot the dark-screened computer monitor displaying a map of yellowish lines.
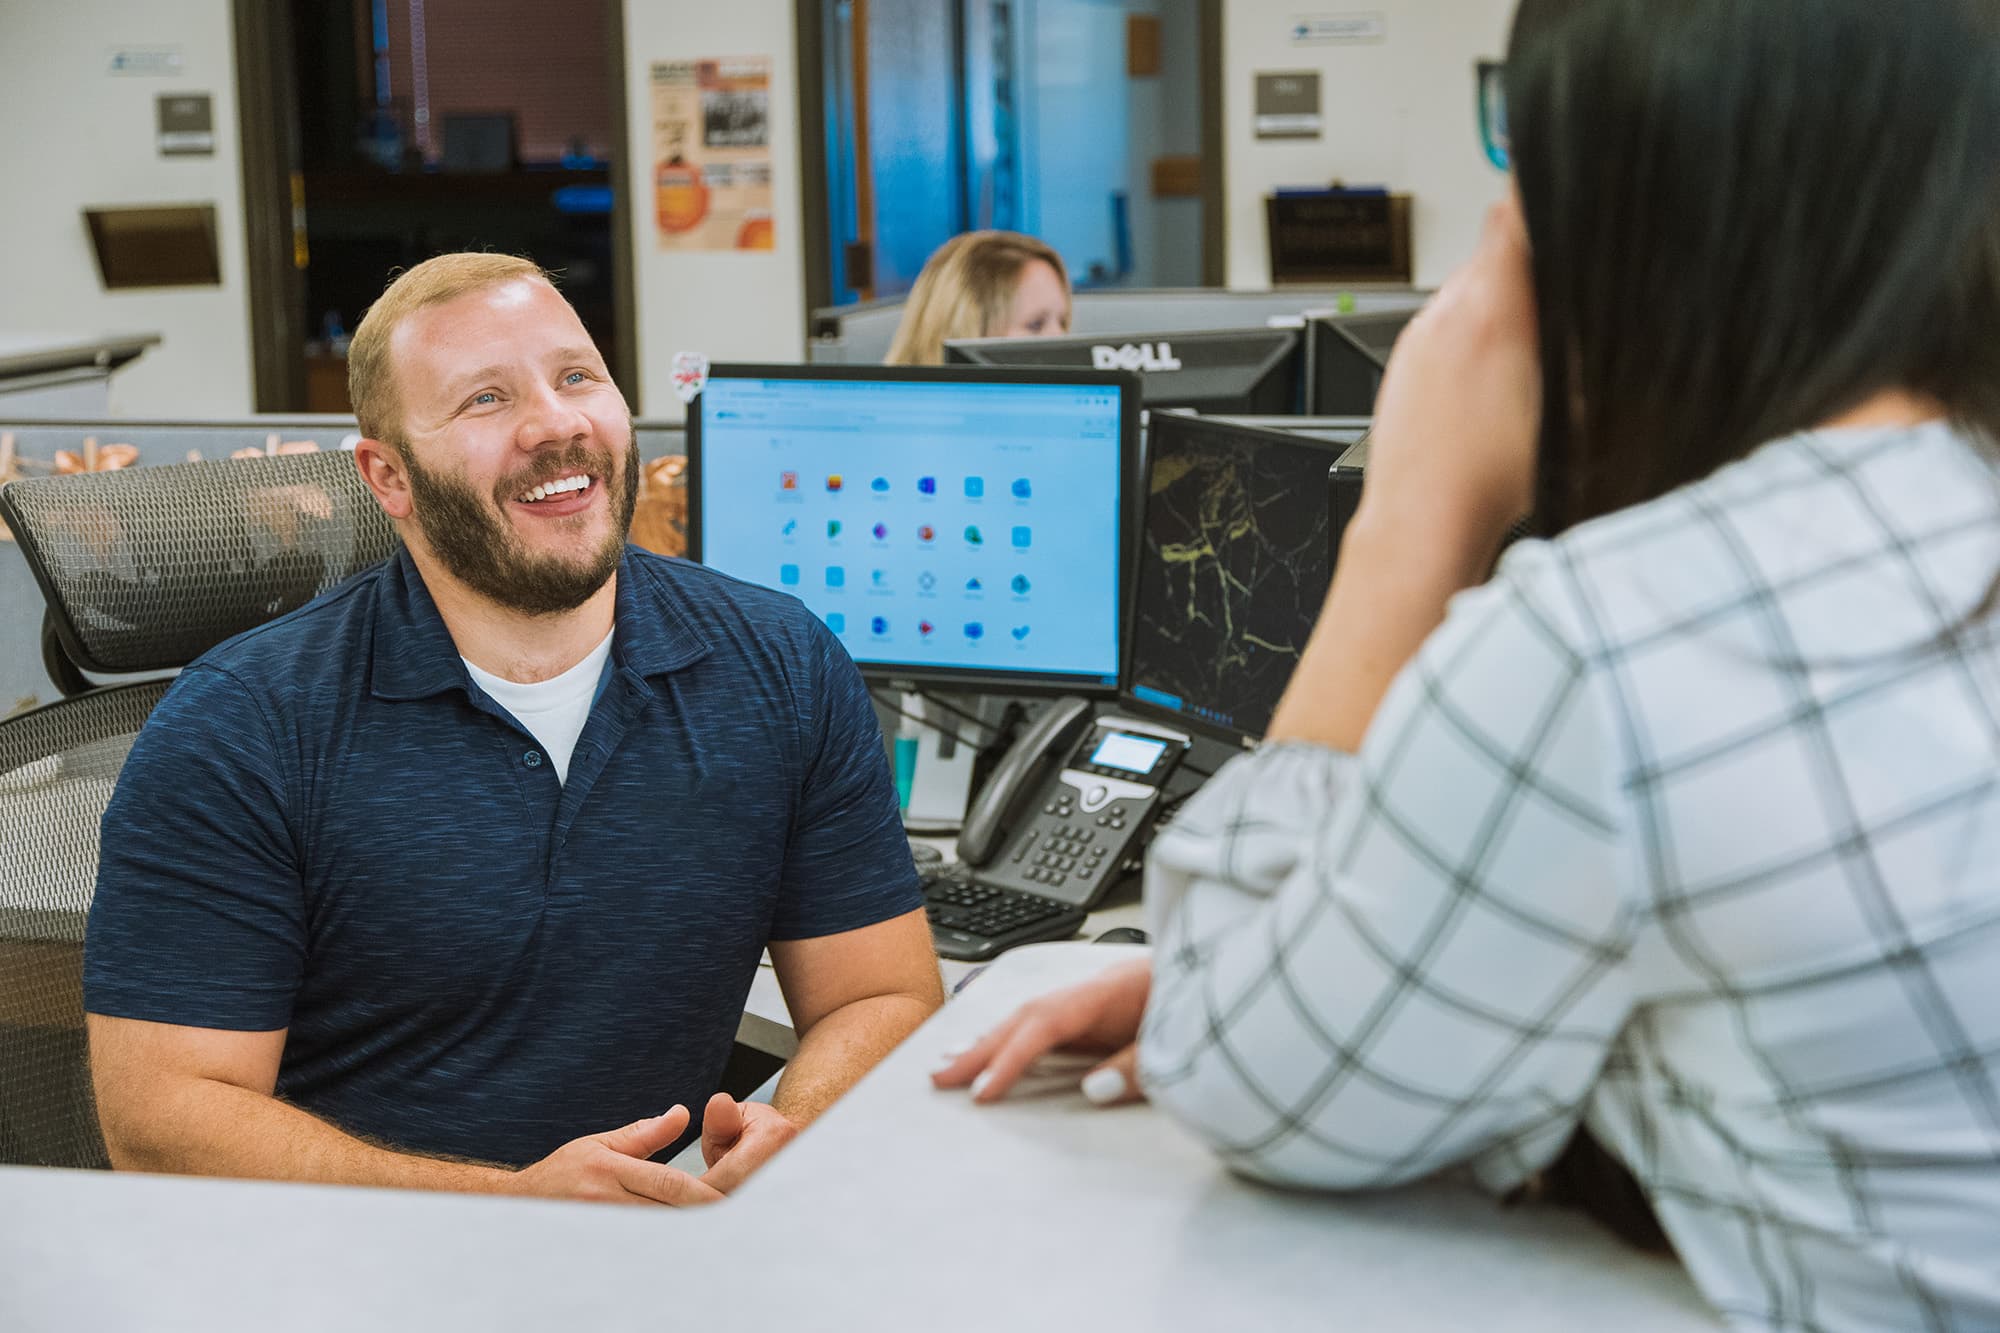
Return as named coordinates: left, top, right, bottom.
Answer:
left=1120, top=416, right=1342, bottom=743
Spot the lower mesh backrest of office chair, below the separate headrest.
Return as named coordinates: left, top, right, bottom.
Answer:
left=0, top=681, right=168, bottom=1167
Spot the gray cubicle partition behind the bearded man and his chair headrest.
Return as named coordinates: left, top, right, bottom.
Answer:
left=0, top=416, right=686, bottom=717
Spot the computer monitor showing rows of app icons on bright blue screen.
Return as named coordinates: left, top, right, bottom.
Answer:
left=688, top=364, right=1138, bottom=695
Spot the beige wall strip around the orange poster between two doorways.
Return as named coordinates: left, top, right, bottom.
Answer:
left=624, top=0, right=806, bottom=420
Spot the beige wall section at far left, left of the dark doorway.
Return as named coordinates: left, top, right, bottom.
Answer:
left=0, top=0, right=250, bottom=416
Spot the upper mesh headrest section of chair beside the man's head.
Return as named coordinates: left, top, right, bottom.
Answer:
left=0, top=452, right=396, bottom=675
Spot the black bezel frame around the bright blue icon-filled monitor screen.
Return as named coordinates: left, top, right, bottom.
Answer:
left=686, top=362, right=1144, bottom=699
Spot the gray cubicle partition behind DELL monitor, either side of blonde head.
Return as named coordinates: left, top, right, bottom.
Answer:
left=806, top=284, right=1430, bottom=366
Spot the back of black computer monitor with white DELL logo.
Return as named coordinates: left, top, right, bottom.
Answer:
left=944, top=328, right=1306, bottom=416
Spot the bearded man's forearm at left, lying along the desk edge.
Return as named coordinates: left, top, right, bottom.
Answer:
left=104, top=1077, right=514, bottom=1193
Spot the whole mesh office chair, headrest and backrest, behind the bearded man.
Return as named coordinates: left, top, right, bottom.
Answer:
left=0, top=452, right=396, bottom=1167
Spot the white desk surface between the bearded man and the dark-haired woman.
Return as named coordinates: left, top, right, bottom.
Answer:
left=0, top=945, right=1718, bottom=1333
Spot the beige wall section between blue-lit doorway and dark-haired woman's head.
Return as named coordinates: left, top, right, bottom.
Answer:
left=1222, top=0, right=1514, bottom=288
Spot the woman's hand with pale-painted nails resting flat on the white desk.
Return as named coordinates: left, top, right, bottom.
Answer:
left=930, top=959, right=1152, bottom=1107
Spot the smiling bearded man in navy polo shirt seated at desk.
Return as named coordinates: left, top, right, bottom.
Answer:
left=84, top=254, right=942, bottom=1203
